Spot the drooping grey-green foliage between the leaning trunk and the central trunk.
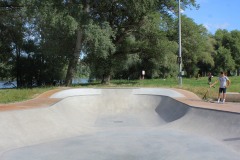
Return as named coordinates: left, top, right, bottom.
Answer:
left=84, top=22, right=115, bottom=78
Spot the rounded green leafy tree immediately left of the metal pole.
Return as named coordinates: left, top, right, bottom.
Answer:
left=133, top=13, right=178, bottom=78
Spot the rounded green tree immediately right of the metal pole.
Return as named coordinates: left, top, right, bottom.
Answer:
left=172, top=15, right=214, bottom=77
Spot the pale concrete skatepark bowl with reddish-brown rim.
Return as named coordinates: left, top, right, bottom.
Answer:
left=0, top=88, right=240, bottom=160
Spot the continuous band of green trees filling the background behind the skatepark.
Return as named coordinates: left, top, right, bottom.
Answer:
left=3, top=0, right=240, bottom=86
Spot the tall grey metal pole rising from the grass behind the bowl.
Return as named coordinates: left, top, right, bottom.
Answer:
left=178, top=0, right=182, bottom=87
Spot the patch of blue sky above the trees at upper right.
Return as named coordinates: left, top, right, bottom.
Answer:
left=183, top=0, right=240, bottom=34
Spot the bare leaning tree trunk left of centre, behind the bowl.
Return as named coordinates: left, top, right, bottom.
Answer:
left=65, top=29, right=83, bottom=86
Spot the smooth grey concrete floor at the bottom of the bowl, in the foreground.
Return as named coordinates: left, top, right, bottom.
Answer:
left=1, top=128, right=239, bottom=160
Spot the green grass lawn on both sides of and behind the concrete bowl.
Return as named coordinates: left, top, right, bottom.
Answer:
left=0, top=77, right=240, bottom=103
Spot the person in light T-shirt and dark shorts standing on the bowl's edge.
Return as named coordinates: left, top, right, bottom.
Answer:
left=210, top=72, right=230, bottom=103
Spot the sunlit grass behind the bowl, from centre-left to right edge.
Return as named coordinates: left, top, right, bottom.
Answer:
left=83, top=77, right=240, bottom=99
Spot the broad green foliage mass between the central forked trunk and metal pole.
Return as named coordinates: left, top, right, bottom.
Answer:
left=113, top=13, right=177, bottom=78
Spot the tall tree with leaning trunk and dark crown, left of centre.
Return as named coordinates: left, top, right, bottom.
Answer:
left=23, top=0, right=87, bottom=85
